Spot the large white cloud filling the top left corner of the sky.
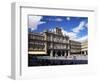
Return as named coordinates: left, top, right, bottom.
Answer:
left=29, top=16, right=45, bottom=30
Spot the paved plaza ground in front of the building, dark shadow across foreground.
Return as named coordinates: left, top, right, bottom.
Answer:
left=28, top=55, right=88, bottom=66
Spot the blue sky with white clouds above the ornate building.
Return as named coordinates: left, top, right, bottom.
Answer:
left=28, top=15, right=88, bottom=41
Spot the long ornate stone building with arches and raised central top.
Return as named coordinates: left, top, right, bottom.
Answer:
left=28, top=28, right=87, bottom=57
